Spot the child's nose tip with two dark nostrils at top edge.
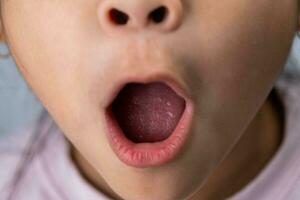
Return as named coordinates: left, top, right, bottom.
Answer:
left=98, top=0, right=183, bottom=34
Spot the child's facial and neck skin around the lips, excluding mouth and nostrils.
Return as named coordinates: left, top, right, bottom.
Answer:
left=1, top=0, right=300, bottom=200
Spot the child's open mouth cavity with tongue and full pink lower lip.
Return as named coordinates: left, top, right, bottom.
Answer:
left=106, top=81, right=193, bottom=167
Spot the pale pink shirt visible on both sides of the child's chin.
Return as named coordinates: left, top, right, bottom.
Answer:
left=0, top=76, right=300, bottom=200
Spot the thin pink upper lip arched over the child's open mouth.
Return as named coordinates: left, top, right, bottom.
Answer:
left=104, top=72, right=191, bottom=108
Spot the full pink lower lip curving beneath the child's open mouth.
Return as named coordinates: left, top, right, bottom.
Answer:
left=106, top=102, right=194, bottom=168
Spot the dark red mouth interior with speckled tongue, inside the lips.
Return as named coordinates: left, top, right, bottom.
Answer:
left=112, top=82, right=185, bottom=143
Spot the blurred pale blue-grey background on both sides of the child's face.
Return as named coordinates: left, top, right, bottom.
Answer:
left=0, top=37, right=300, bottom=136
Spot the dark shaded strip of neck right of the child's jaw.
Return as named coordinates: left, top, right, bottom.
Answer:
left=189, top=90, right=284, bottom=200
